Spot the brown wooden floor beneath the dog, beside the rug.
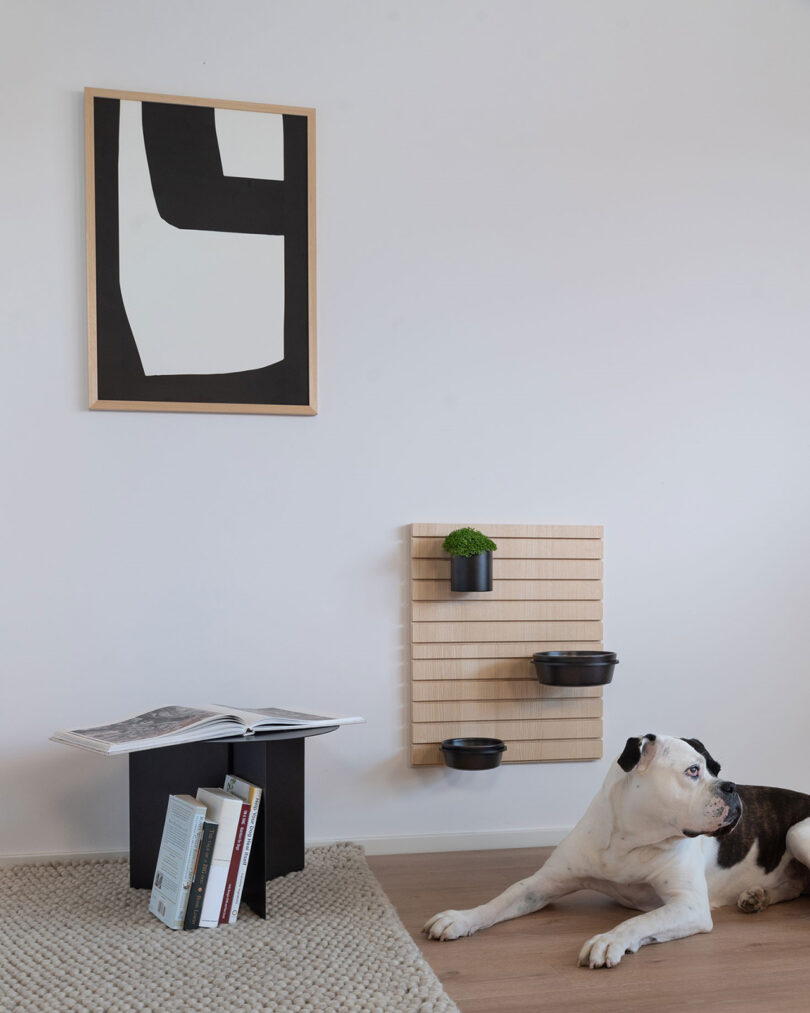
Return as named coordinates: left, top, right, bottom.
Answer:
left=369, top=848, right=810, bottom=1013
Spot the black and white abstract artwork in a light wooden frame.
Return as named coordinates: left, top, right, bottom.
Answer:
left=84, top=88, right=316, bottom=415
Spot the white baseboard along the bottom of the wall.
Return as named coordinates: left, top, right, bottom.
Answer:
left=0, top=827, right=571, bottom=868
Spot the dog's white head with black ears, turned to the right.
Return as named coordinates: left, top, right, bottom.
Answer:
left=617, top=732, right=742, bottom=837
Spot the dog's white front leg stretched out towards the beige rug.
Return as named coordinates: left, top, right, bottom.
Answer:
left=422, top=863, right=579, bottom=941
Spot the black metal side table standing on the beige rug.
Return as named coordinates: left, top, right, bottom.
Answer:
left=130, top=724, right=338, bottom=918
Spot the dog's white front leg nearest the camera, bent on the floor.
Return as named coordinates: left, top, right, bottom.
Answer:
left=577, top=886, right=712, bottom=967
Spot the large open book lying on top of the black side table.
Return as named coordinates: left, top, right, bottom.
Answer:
left=51, top=704, right=365, bottom=756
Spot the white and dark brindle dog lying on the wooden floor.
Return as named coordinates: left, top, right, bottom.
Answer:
left=424, top=734, right=810, bottom=967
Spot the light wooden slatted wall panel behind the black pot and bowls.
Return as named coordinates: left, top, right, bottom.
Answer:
left=411, top=524, right=602, bottom=765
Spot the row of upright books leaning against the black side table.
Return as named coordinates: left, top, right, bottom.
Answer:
left=149, top=774, right=261, bottom=929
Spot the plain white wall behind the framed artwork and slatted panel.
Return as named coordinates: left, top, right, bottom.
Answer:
left=0, top=0, right=810, bottom=855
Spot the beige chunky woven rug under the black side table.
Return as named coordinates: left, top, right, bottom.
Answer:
left=0, top=844, right=458, bottom=1013
